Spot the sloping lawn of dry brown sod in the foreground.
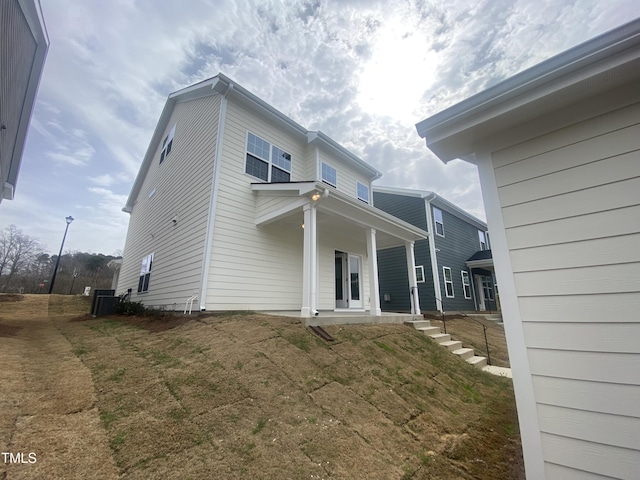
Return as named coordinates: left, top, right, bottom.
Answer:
left=0, top=295, right=524, bottom=480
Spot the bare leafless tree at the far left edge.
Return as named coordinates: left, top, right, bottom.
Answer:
left=0, top=225, right=43, bottom=292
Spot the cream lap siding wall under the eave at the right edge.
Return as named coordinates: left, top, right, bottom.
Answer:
left=493, top=100, right=640, bottom=478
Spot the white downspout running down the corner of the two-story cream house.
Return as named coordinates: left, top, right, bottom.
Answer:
left=200, top=84, right=233, bottom=311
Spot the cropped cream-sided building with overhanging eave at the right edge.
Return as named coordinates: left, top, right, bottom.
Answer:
left=417, top=20, right=640, bottom=479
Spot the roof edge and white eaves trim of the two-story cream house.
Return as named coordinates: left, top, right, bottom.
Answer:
left=122, top=73, right=382, bottom=213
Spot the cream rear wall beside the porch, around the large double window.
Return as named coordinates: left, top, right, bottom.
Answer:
left=206, top=99, right=308, bottom=310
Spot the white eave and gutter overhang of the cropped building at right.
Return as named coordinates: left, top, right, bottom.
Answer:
left=416, top=19, right=640, bottom=162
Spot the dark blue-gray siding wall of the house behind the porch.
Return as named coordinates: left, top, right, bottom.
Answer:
left=431, top=199, right=480, bottom=313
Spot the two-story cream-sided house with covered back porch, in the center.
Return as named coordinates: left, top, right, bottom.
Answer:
left=122, top=74, right=427, bottom=317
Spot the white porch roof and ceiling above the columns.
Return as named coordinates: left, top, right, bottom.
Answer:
left=252, top=182, right=429, bottom=249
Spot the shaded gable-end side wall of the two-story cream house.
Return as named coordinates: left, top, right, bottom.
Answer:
left=117, top=95, right=220, bottom=308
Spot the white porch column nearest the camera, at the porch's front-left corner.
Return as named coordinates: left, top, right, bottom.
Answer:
left=300, top=203, right=318, bottom=318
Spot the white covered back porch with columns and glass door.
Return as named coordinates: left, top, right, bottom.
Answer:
left=252, top=181, right=428, bottom=324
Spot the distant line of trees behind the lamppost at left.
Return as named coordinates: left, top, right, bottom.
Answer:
left=0, top=225, right=122, bottom=295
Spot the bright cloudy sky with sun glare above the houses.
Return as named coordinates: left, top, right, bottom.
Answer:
left=0, top=0, right=640, bottom=254
